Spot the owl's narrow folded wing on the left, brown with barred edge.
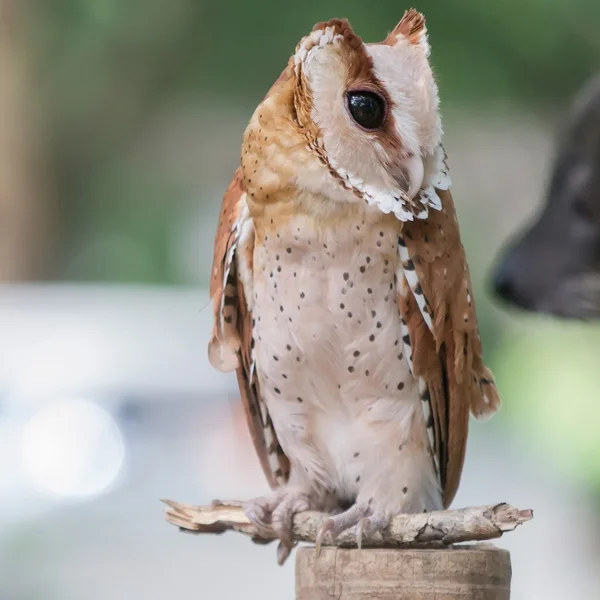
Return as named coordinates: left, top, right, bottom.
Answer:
left=208, top=169, right=290, bottom=488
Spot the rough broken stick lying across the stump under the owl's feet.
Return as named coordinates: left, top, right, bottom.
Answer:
left=163, top=500, right=533, bottom=547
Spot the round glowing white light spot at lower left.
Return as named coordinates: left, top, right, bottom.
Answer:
left=21, top=399, right=125, bottom=497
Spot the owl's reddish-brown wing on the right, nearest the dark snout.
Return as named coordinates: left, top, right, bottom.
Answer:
left=398, top=189, right=500, bottom=506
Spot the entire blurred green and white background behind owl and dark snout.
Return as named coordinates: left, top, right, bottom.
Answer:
left=0, top=0, right=600, bottom=600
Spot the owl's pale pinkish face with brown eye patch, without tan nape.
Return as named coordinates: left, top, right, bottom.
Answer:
left=290, top=10, right=449, bottom=220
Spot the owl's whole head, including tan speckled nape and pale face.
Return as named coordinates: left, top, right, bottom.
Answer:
left=242, top=10, right=450, bottom=221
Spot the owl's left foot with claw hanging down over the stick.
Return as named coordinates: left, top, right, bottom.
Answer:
left=243, top=489, right=315, bottom=565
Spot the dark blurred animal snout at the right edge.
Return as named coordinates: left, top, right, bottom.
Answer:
left=492, top=75, right=600, bottom=319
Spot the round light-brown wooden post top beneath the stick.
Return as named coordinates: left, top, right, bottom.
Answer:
left=296, top=544, right=512, bottom=600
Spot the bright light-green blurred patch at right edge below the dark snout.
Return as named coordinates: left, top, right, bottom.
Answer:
left=495, top=322, right=600, bottom=499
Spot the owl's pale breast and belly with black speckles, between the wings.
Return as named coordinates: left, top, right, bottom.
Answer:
left=253, top=216, right=418, bottom=494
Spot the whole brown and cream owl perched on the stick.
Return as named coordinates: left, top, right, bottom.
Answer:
left=208, top=10, right=500, bottom=562
